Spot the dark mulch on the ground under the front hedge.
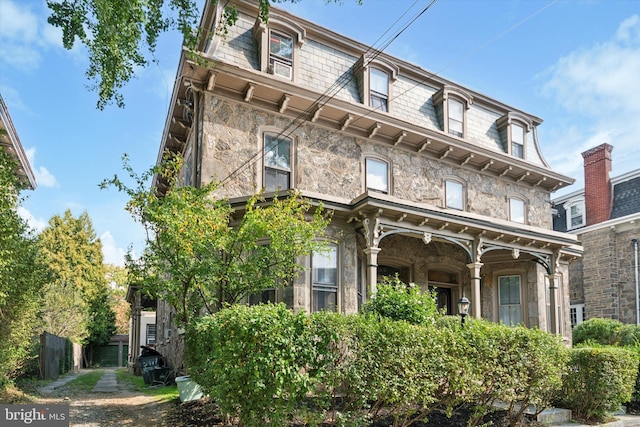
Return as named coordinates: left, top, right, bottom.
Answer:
left=165, top=398, right=538, bottom=427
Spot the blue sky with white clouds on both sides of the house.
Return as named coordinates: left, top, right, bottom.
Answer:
left=0, top=0, right=640, bottom=265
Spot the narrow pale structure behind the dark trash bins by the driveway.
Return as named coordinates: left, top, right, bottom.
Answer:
left=126, top=285, right=156, bottom=372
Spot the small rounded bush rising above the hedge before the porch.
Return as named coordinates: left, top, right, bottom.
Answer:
left=362, top=276, right=438, bottom=325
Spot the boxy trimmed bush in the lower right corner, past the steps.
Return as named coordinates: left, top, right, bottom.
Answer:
left=562, top=347, right=638, bottom=421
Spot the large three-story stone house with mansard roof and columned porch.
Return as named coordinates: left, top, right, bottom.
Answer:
left=154, top=1, right=582, bottom=368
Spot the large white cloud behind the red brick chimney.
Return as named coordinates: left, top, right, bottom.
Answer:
left=541, top=15, right=640, bottom=192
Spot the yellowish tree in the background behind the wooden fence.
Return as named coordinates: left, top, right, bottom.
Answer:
left=39, top=210, right=115, bottom=352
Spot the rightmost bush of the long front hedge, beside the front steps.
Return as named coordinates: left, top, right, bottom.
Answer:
left=461, top=319, right=567, bottom=425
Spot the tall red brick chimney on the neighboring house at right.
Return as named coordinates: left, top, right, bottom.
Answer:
left=582, top=144, right=613, bottom=225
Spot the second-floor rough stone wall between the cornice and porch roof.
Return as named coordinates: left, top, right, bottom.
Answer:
left=202, top=94, right=551, bottom=229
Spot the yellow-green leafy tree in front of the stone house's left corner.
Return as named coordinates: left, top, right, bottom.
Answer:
left=102, top=156, right=329, bottom=325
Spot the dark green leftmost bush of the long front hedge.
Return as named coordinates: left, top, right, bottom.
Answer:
left=185, top=304, right=318, bottom=427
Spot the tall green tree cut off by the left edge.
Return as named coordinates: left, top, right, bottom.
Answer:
left=0, top=147, right=45, bottom=390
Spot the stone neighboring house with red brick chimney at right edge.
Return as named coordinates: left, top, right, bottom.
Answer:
left=553, top=144, right=640, bottom=326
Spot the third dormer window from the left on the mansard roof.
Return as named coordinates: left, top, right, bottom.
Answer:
left=433, top=85, right=473, bottom=138
